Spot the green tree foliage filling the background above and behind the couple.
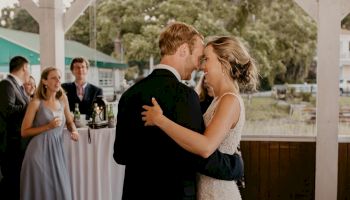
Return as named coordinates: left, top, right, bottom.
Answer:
left=1, top=0, right=322, bottom=87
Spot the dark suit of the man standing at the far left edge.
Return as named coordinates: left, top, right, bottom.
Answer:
left=0, top=76, right=29, bottom=199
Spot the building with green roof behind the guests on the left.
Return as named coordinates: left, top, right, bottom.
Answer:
left=0, top=28, right=128, bottom=95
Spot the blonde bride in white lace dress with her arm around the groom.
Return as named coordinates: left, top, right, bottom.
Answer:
left=142, top=36, right=258, bottom=200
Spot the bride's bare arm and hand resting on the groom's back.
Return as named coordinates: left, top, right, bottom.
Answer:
left=142, top=95, right=240, bottom=158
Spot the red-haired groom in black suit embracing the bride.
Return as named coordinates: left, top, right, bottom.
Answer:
left=113, top=23, right=243, bottom=200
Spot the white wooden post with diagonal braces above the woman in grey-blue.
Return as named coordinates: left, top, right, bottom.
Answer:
left=19, top=0, right=94, bottom=81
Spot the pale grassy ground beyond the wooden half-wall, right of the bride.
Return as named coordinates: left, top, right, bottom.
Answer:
left=243, top=96, right=350, bottom=136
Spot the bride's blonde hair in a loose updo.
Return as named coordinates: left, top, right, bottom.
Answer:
left=206, top=36, right=258, bottom=91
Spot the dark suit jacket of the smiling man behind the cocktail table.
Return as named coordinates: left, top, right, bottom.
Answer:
left=62, top=82, right=103, bottom=119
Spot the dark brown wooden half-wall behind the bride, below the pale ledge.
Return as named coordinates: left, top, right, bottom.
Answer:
left=241, top=136, right=350, bottom=200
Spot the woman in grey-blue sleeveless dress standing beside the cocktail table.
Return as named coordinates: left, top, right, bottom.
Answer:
left=20, top=67, right=79, bottom=200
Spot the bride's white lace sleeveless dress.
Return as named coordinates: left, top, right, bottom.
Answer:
left=197, top=93, right=245, bottom=200
